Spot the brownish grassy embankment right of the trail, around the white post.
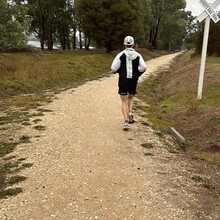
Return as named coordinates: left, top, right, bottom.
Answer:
left=139, top=51, right=220, bottom=162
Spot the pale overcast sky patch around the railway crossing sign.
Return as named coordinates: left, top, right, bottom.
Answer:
left=186, top=0, right=220, bottom=16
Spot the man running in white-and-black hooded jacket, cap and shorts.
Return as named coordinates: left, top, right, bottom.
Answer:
left=111, top=36, right=146, bottom=130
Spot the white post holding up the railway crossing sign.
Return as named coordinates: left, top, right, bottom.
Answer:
left=197, top=16, right=210, bottom=99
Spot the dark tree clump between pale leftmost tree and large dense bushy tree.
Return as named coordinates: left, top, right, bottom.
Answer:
left=27, top=0, right=73, bottom=50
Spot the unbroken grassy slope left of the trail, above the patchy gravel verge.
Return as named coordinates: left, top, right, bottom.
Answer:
left=0, top=51, right=113, bottom=102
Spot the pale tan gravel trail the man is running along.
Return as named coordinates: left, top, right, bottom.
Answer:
left=0, top=54, right=219, bottom=220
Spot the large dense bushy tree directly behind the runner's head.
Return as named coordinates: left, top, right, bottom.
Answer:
left=75, top=0, right=143, bottom=52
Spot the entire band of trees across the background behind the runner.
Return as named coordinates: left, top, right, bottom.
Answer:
left=0, top=0, right=213, bottom=55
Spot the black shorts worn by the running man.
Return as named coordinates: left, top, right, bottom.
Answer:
left=118, top=78, right=137, bottom=95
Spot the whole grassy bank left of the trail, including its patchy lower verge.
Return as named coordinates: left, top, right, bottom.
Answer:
left=0, top=49, right=163, bottom=198
